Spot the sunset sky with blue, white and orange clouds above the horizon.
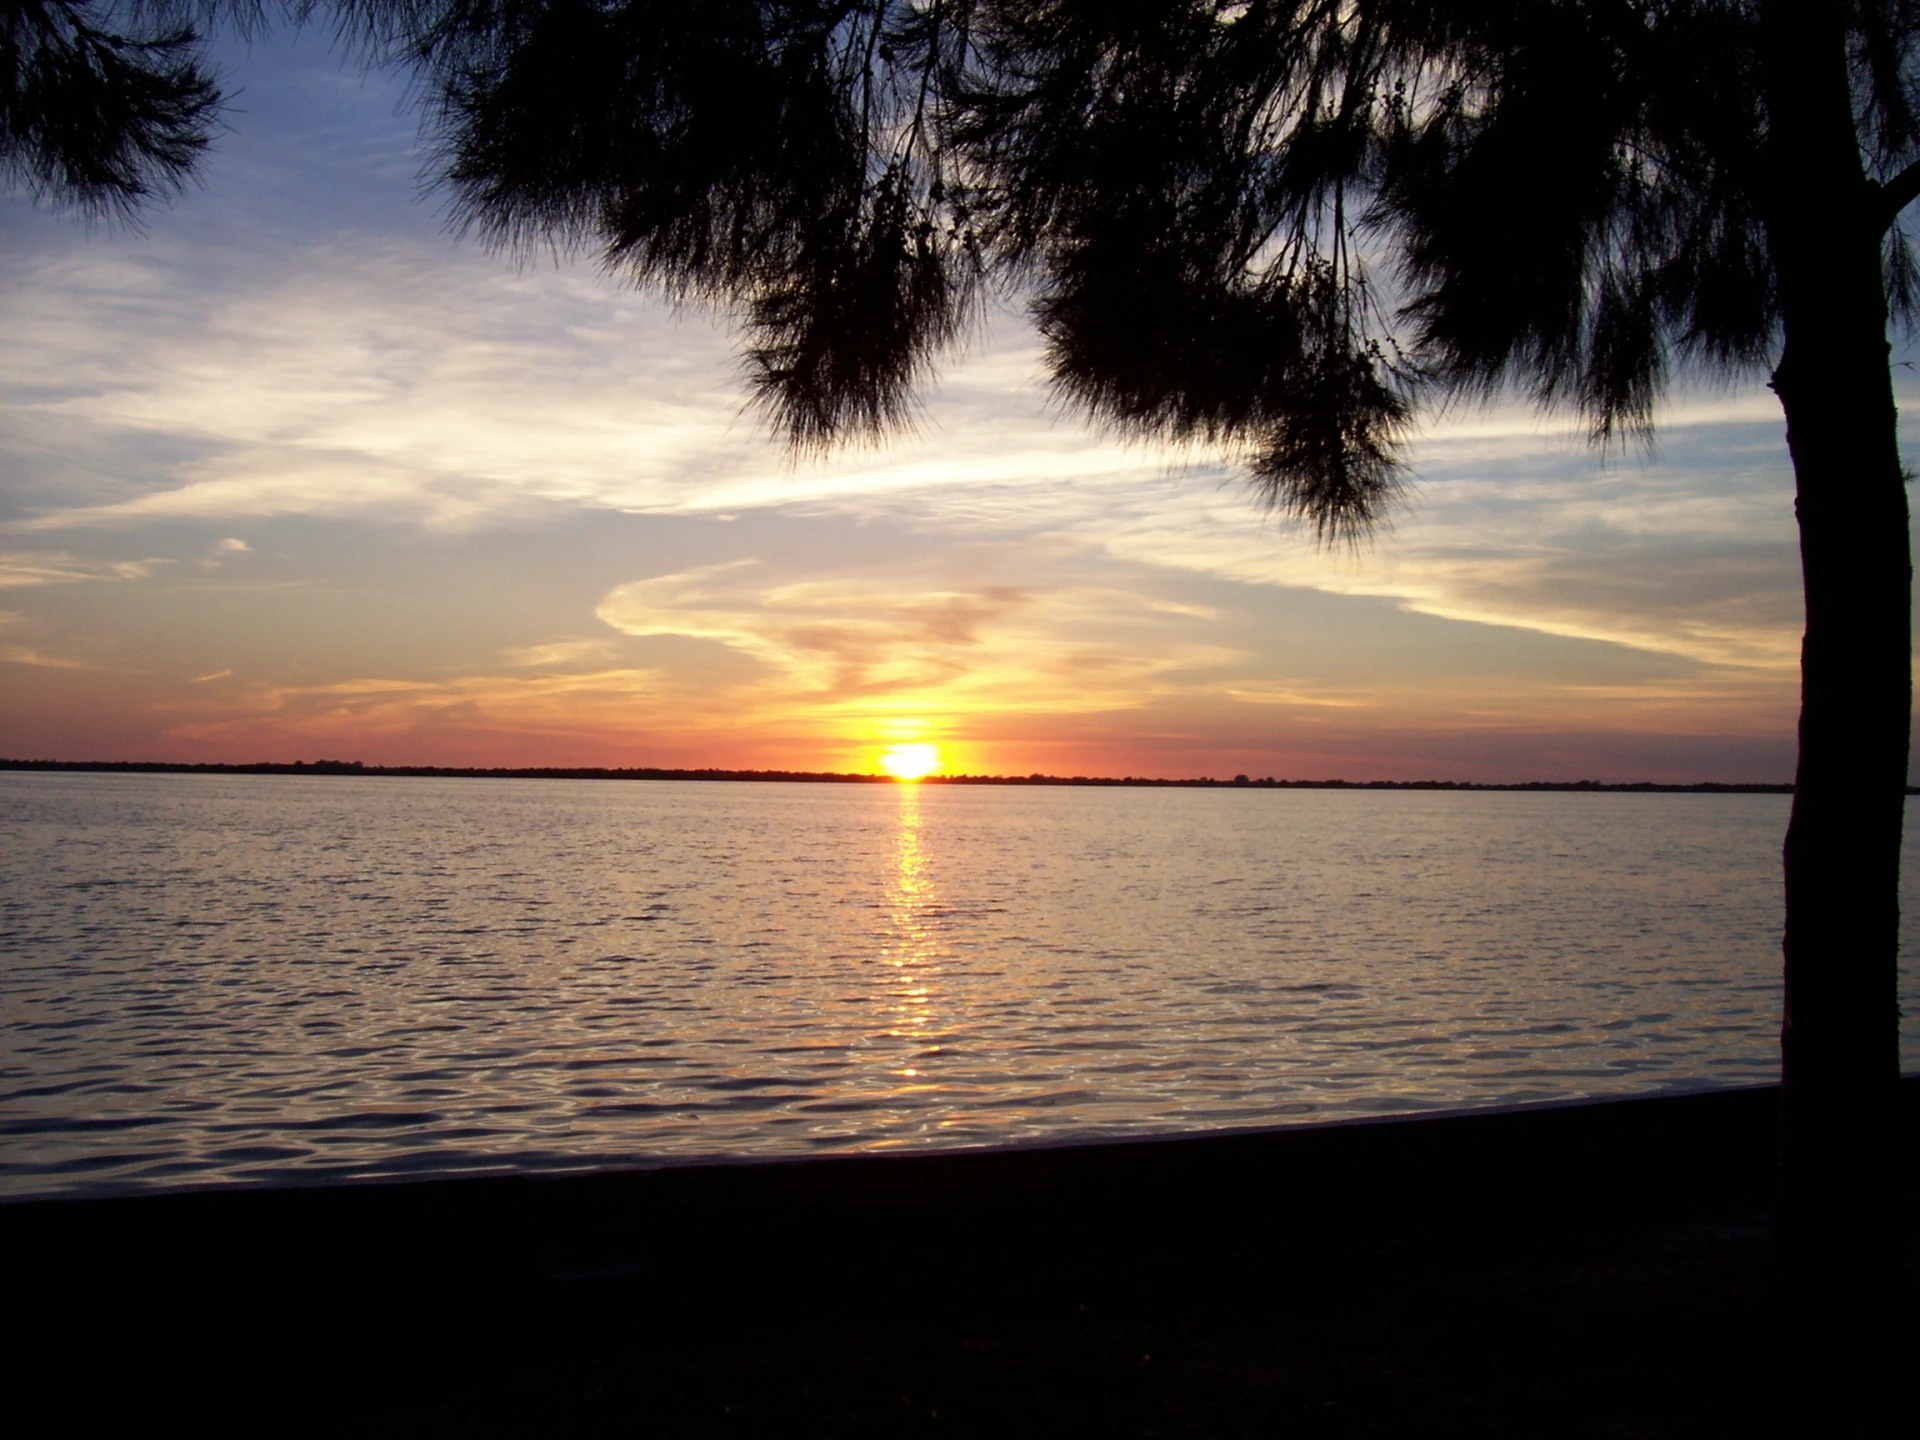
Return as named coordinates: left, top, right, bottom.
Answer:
left=0, top=36, right=1889, bottom=781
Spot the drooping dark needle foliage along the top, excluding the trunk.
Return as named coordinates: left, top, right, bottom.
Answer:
left=11, top=0, right=1920, bottom=538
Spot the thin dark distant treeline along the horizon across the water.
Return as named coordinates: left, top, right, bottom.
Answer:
left=0, top=758, right=1835, bottom=795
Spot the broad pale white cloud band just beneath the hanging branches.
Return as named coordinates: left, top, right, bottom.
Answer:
left=0, top=216, right=1799, bottom=687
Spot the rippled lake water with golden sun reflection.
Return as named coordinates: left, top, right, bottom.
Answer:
left=0, top=772, right=1920, bottom=1196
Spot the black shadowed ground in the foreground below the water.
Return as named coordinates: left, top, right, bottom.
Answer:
left=0, top=1081, right=1920, bottom=1436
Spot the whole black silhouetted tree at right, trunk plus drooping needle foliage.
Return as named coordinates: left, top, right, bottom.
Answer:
left=382, top=0, right=1920, bottom=1313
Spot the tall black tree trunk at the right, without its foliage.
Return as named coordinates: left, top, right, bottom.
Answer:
left=1761, top=0, right=1912, bottom=1380
